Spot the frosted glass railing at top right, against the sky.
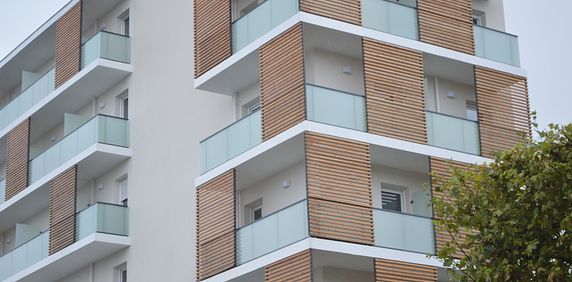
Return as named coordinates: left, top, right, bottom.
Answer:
left=474, top=25, right=520, bottom=66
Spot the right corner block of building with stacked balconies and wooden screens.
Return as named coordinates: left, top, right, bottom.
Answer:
left=194, top=0, right=531, bottom=282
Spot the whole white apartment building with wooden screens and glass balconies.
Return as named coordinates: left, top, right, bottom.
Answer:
left=0, top=0, right=530, bottom=282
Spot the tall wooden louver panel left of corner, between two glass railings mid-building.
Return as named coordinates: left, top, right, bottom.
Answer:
left=260, top=24, right=306, bottom=140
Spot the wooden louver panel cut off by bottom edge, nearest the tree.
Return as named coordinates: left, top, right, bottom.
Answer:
left=375, top=259, right=437, bottom=282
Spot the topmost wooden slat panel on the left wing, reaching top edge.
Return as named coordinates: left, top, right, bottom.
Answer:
left=55, top=1, right=82, bottom=88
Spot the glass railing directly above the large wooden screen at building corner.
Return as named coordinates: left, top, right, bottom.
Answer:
left=306, top=85, right=366, bottom=131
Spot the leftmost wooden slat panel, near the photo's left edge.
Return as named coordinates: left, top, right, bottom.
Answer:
left=5, top=118, right=30, bottom=201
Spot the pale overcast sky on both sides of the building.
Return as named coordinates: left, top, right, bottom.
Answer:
left=0, top=0, right=572, bottom=128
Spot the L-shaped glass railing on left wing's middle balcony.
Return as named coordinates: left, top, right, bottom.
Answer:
left=30, top=115, right=129, bottom=183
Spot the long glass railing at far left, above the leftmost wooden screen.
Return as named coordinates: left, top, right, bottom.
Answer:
left=0, top=69, right=55, bottom=131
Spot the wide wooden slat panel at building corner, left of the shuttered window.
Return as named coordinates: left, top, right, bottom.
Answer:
left=305, top=132, right=373, bottom=245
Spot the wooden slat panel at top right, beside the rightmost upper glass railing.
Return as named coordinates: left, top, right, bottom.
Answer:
left=417, top=0, right=475, bottom=55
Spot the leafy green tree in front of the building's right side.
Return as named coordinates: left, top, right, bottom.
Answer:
left=432, top=124, right=572, bottom=281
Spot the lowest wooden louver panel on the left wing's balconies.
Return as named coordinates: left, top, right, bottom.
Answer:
left=49, top=166, right=77, bottom=255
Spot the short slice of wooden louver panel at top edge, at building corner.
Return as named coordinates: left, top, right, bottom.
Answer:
left=300, top=0, right=361, bottom=25
